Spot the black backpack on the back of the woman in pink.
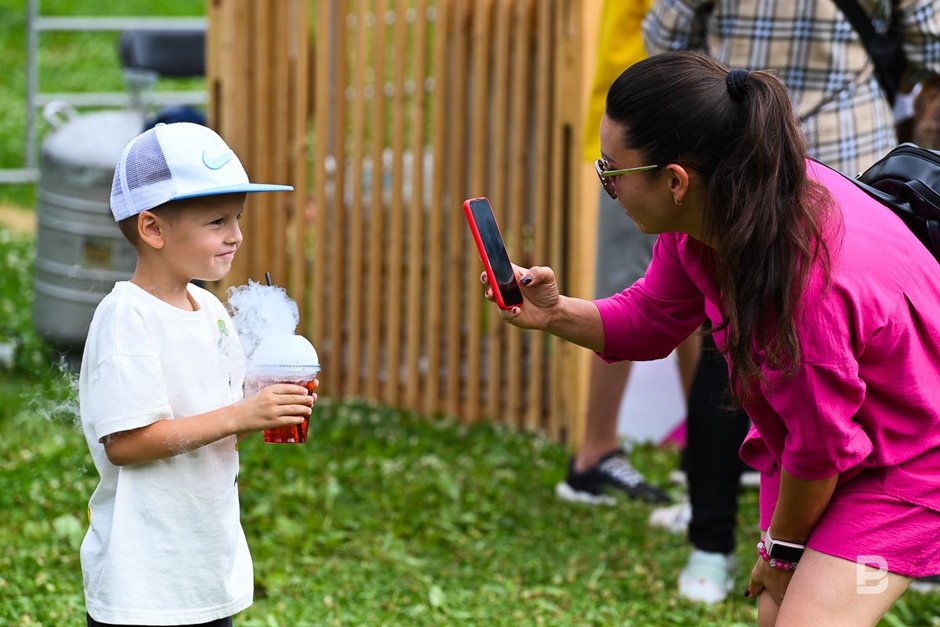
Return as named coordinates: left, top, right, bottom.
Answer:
left=852, top=143, right=940, bottom=263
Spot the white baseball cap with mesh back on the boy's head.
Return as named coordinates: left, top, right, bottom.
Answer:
left=111, top=122, right=294, bottom=221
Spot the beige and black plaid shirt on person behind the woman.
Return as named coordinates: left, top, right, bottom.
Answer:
left=643, top=0, right=940, bottom=176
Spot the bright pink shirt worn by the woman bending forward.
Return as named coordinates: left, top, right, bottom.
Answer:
left=595, top=162, right=940, bottom=511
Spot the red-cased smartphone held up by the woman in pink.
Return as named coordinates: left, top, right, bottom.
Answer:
left=463, top=196, right=522, bottom=309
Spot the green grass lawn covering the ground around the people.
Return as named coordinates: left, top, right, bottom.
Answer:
left=0, top=0, right=940, bottom=627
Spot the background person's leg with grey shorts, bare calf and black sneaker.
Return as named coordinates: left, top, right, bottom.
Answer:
left=556, top=191, right=688, bottom=504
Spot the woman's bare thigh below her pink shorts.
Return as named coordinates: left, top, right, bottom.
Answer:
left=759, top=549, right=911, bottom=627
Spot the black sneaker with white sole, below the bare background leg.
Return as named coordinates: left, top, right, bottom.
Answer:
left=555, top=449, right=672, bottom=505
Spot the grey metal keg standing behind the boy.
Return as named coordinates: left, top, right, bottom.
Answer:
left=33, top=103, right=144, bottom=351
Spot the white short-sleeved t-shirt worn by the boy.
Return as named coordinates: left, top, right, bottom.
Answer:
left=79, top=282, right=253, bottom=625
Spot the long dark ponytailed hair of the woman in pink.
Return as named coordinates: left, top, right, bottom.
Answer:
left=606, top=52, right=831, bottom=401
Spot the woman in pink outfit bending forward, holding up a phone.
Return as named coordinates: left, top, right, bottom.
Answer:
left=488, top=52, right=940, bottom=625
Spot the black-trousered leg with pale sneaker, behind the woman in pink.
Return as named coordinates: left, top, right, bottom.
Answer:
left=679, top=335, right=750, bottom=603
